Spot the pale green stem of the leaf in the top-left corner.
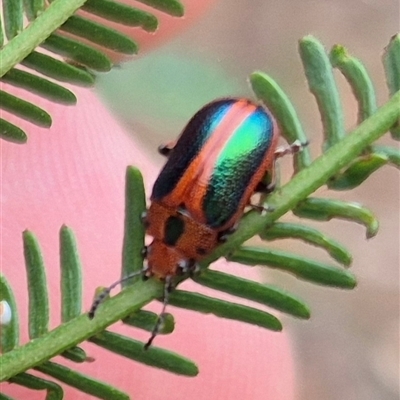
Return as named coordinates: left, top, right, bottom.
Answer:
left=0, top=0, right=86, bottom=77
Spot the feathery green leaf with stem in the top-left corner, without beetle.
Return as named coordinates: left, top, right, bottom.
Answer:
left=0, top=0, right=183, bottom=143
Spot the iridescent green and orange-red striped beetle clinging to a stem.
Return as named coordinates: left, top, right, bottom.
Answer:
left=89, top=98, right=299, bottom=348
